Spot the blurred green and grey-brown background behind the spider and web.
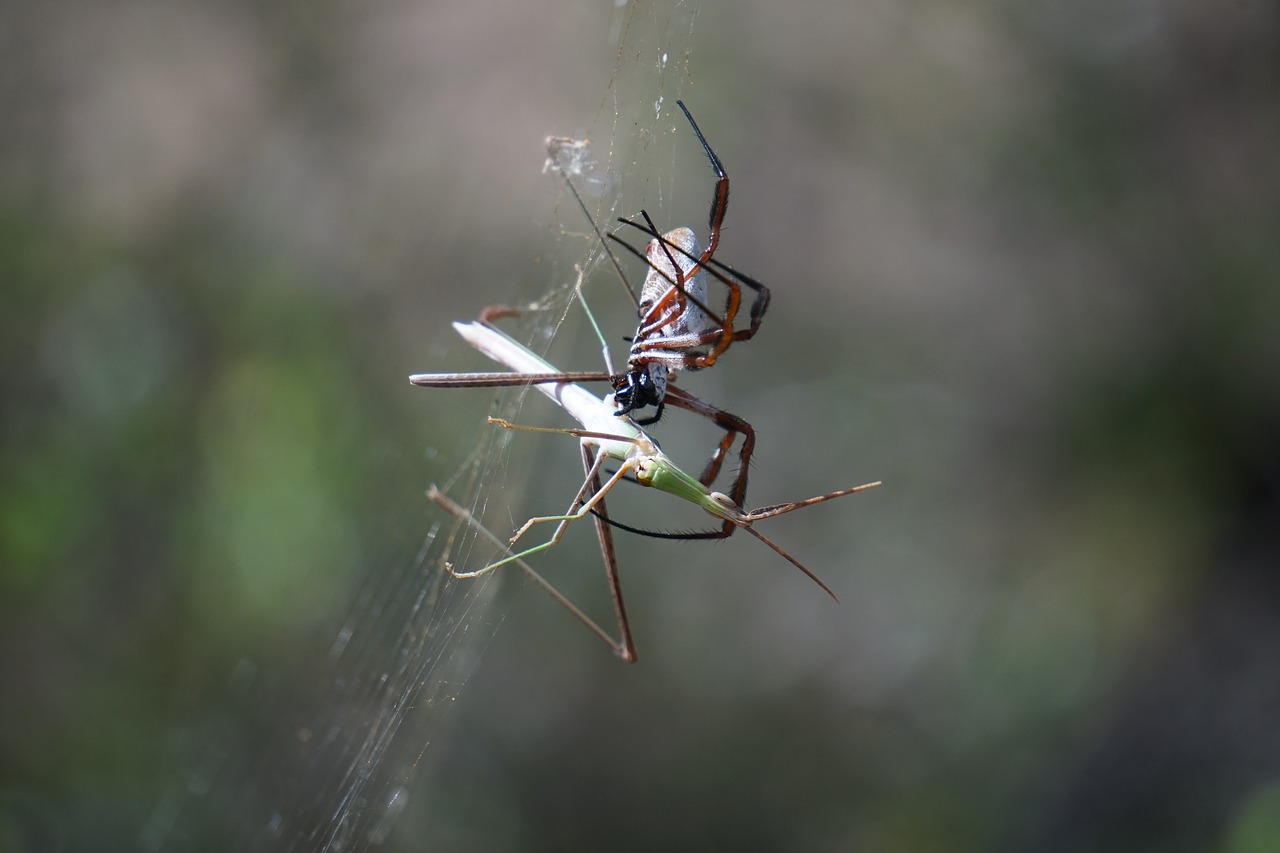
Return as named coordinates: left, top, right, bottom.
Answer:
left=0, top=0, right=1280, bottom=853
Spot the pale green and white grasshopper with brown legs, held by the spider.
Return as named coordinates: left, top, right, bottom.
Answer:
left=410, top=323, right=879, bottom=661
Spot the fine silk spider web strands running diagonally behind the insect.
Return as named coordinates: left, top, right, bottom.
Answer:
left=142, top=0, right=698, bottom=850
